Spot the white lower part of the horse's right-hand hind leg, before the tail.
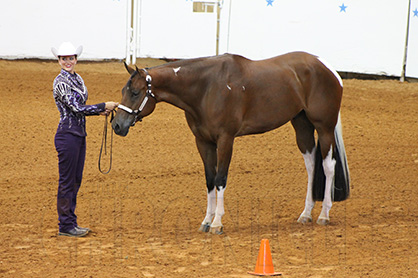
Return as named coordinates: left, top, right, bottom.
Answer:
left=317, top=146, right=336, bottom=225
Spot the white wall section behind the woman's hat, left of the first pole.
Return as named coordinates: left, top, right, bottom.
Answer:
left=0, top=0, right=126, bottom=59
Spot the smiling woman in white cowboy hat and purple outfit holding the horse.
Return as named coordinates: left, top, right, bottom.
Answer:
left=51, top=42, right=118, bottom=237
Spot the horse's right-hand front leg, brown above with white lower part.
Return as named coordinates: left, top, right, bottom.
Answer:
left=210, top=136, right=234, bottom=234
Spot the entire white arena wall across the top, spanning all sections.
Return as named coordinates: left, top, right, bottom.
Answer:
left=0, top=0, right=418, bottom=78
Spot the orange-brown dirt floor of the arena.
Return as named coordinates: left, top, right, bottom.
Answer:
left=0, top=59, right=418, bottom=278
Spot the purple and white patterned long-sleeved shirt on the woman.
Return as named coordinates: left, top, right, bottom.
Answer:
left=53, top=69, right=105, bottom=136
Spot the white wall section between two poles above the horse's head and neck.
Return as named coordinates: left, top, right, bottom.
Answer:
left=138, top=0, right=217, bottom=58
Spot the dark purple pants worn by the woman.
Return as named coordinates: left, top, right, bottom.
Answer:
left=55, top=132, right=86, bottom=232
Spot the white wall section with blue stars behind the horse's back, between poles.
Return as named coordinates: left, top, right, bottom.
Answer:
left=222, top=0, right=408, bottom=76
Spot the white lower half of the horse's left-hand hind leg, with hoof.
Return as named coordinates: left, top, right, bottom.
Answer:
left=298, top=148, right=316, bottom=224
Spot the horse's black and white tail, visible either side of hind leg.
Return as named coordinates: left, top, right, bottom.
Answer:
left=312, top=115, right=350, bottom=202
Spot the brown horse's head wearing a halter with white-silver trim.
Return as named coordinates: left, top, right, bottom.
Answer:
left=112, top=64, right=156, bottom=136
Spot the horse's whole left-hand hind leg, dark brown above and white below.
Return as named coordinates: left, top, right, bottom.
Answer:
left=291, top=111, right=315, bottom=224
